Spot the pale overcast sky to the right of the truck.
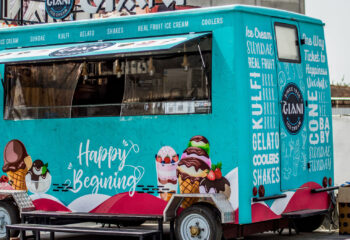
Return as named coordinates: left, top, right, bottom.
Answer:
left=305, top=0, right=350, bottom=85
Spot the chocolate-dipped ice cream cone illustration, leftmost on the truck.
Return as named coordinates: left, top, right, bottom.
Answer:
left=2, top=139, right=32, bottom=190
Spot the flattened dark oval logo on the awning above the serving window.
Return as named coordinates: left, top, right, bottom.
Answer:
left=49, top=42, right=115, bottom=57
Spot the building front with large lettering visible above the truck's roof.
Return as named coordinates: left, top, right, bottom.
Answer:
left=0, top=0, right=305, bottom=27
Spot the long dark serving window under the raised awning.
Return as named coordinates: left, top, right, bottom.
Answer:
left=4, top=36, right=211, bottom=120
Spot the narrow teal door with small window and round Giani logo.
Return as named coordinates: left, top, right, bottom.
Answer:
left=272, top=19, right=308, bottom=191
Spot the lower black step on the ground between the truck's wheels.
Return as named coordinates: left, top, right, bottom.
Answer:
left=6, top=223, right=161, bottom=240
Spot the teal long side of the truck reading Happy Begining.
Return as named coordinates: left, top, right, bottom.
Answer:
left=0, top=9, right=244, bottom=218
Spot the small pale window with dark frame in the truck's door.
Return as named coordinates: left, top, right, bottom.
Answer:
left=275, top=23, right=300, bottom=63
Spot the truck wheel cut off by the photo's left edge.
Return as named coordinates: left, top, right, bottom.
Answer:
left=0, top=201, right=20, bottom=240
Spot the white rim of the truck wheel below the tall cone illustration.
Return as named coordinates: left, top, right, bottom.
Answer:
left=180, top=214, right=210, bottom=240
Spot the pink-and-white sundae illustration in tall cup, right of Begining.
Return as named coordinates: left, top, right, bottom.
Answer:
left=155, top=146, right=179, bottom=201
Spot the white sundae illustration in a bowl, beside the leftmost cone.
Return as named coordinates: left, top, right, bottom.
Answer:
left=26, top=159, right=51, bottom=193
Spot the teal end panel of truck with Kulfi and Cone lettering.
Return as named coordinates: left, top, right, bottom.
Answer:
left=240, top=14, right=333, bottom=222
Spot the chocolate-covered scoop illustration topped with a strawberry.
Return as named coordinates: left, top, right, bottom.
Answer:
left=199, top=163, right=231, bottom=198
